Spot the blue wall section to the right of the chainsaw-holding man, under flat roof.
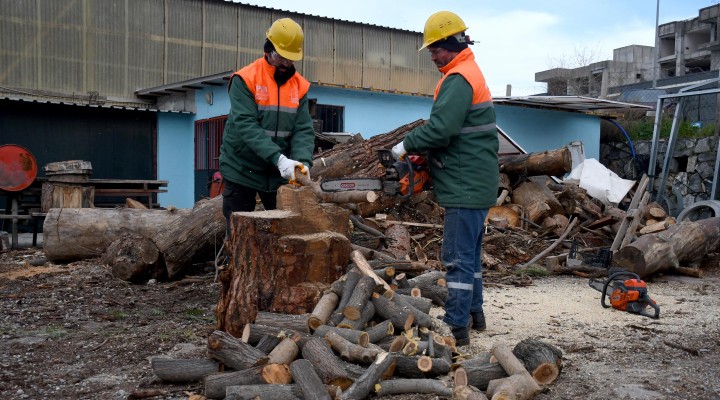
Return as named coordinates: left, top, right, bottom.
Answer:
left=495, top=105, right=600, bottom=160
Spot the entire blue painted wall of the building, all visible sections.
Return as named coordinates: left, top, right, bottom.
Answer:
left=158, top=85, right=600, bottom=208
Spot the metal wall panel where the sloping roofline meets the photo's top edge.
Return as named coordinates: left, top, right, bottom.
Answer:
left=202, top=2, right=238, bottom=75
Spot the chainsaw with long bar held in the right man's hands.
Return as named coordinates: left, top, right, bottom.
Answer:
left=320, top=150, right=430, bottom=199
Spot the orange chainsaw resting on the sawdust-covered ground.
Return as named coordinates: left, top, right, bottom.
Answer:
left=589, top=271, right=660, bottom=319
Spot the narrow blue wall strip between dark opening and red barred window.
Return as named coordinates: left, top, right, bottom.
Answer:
left=157, top=113, right=195, bottom=208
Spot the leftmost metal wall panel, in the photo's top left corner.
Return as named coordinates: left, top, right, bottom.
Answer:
left=0, top=0, right=40, bottom=89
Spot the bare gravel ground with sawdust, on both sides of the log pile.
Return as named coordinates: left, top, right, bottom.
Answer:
left=0, top=249, right=720, bottom=400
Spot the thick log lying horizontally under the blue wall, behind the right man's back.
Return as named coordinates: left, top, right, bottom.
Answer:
left=498, top=147, right=572, bottom=176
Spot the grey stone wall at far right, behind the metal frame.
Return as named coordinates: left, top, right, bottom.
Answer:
left=600, top=137, right=718, bottom=208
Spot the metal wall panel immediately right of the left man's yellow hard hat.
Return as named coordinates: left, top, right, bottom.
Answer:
left=300, top=17, right=336, bottom=83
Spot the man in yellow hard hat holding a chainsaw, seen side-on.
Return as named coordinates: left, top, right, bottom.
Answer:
left=392, top=11, right=500, bottom=346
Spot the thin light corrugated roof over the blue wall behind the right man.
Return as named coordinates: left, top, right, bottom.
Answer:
left=493, top=96, right=652, bottom=113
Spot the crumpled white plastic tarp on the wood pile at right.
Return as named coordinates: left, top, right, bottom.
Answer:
left=565, top=158, right=635, bottom=205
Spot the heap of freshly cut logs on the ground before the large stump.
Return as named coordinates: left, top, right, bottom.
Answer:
left=151, top=251, right=562, bottom=399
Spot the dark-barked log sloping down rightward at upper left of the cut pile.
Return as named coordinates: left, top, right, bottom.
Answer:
left=208, top=331, right=268, bottom=370
